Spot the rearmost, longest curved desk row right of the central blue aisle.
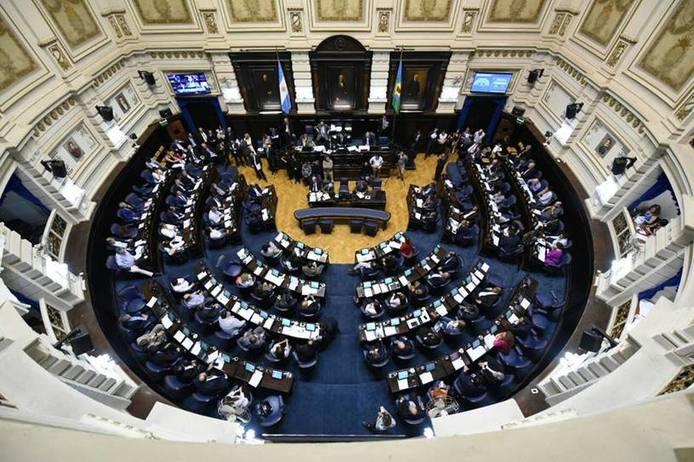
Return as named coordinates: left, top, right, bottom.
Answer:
left=386, top=278, right=537, bottom=393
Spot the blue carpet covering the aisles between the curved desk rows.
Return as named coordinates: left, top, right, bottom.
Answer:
left=111, top=162, right=566, bottom=435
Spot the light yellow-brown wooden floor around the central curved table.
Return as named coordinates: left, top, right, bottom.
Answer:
left=240, top=155, right=436, bottom=263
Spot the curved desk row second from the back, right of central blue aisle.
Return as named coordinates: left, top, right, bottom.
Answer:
left=359, top=261, right=489, bottom=342
